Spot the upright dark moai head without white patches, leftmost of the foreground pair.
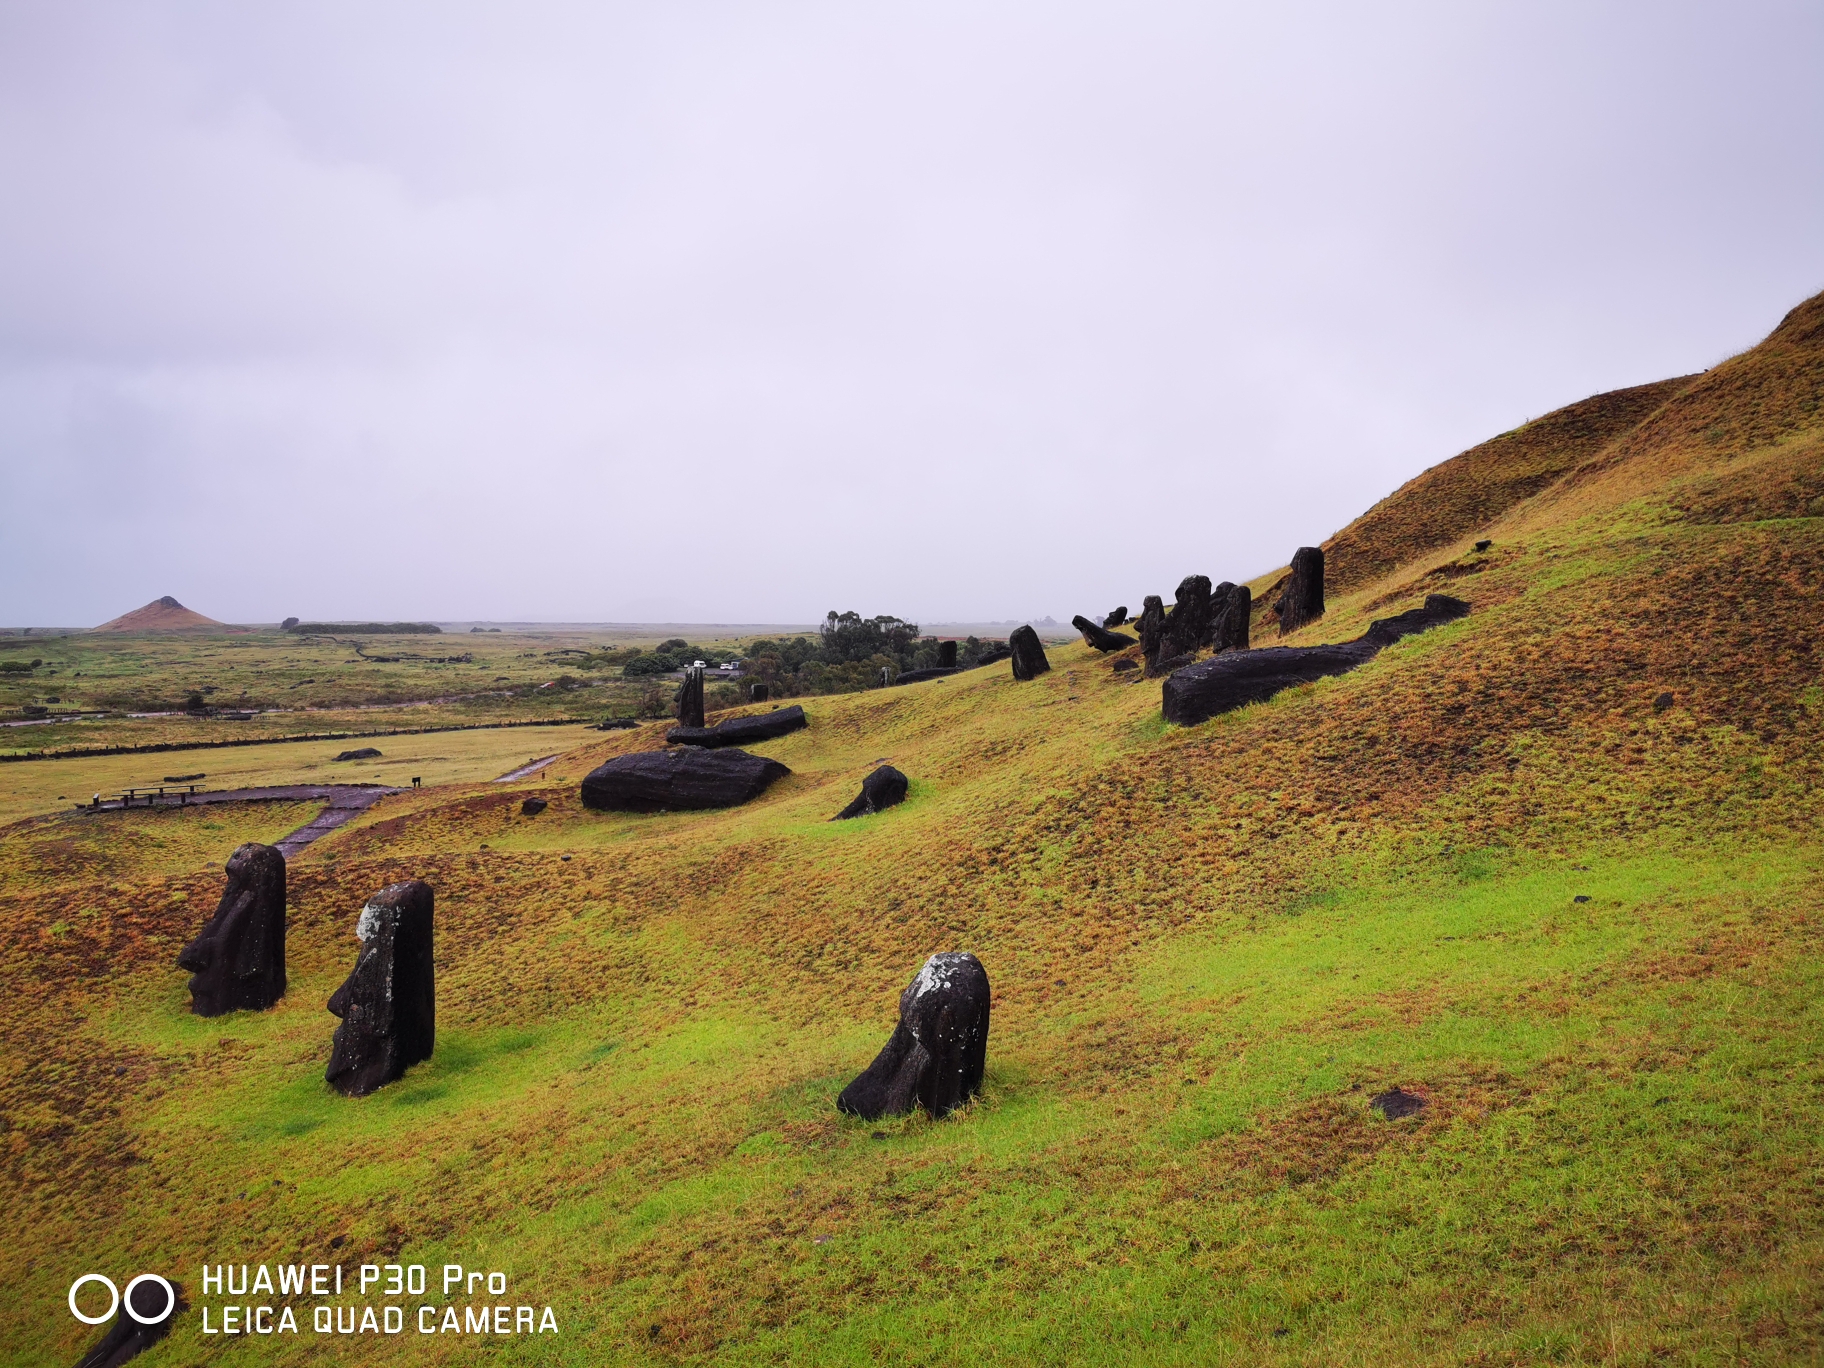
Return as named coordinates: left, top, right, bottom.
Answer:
left=177, top=841, right=285, bottom=1016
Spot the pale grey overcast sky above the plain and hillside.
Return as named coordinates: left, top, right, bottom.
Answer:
left=0, top=0, right=1824, bottom=626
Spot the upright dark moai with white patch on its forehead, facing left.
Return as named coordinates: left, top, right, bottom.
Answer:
left=323, top=879, right=438, bottom=1098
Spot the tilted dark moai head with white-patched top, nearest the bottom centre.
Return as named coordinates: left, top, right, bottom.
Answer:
left=835, top=950, right=989, bottom=1122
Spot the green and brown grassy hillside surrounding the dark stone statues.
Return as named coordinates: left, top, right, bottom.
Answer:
left=0, top=291, right=1824, bottom=1364
